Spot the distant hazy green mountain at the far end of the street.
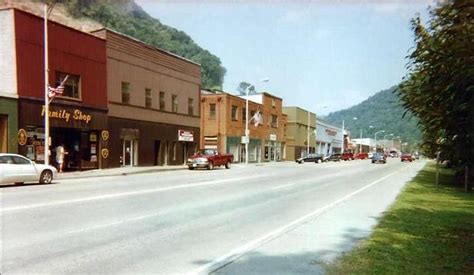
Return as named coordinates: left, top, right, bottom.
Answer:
left=324, top=86, right=421, bottom=146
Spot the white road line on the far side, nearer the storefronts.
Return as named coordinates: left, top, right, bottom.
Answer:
left=0, top=175, right=266, bottom=215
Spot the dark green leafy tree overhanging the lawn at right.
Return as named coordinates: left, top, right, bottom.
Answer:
left=399, top=0, right=474, bottom=171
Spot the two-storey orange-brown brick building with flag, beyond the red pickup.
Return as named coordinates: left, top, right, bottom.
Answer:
left=201, top=91, right=286, bottom=162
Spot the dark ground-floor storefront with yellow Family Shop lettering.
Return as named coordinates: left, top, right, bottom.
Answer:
left=18, top=100, right=109, bottom=171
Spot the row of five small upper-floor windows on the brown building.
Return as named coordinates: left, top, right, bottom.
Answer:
left=122, top=82, right=194, bottom=116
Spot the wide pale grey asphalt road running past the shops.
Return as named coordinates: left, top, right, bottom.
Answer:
left=0, top=159, right=424, bottom=274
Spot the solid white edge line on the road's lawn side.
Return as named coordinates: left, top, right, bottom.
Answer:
left=186, top=168, right=404, bottom=275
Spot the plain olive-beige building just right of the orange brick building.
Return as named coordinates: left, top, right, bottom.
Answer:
left=283, top=107, right=316, bottom=160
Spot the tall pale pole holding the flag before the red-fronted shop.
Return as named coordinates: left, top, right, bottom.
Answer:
left=44, top=2, right=49, bottom=165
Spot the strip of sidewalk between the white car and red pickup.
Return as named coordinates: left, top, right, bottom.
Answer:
left=57, top=165, right=188, bottom=179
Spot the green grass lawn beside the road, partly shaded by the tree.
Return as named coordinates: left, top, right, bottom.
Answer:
left=327, top=162, right=474, bottom=274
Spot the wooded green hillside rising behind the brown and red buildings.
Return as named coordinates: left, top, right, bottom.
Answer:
left=56, top=0, right=226, bottom=88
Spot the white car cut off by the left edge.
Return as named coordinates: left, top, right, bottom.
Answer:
left=0, top=154, right=58, bottom=184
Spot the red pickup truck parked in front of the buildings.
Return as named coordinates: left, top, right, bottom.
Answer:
left=187, top=149, right=234, bottom=170
